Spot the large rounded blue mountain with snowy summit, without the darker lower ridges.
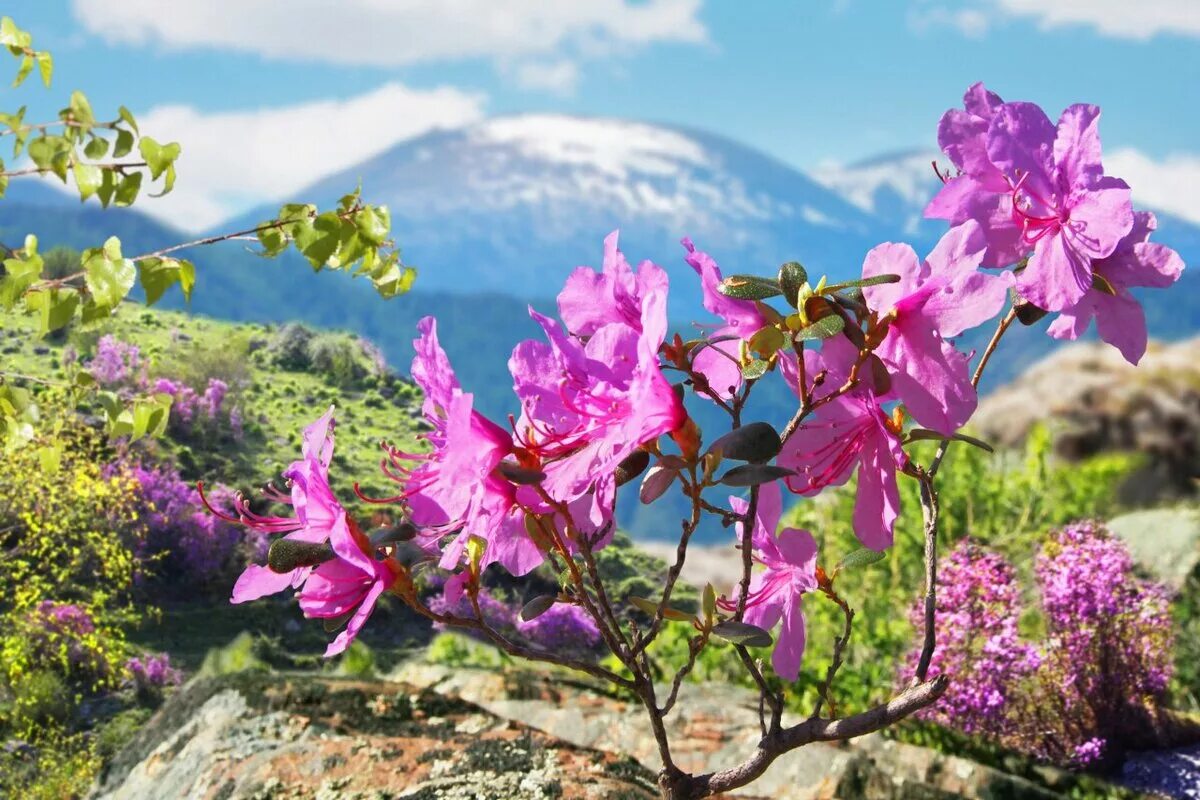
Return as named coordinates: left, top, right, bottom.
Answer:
left=223, top=114, right=883, bottom=313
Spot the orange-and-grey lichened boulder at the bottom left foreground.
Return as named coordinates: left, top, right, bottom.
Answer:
left=94, top=673, right=656, bottom=800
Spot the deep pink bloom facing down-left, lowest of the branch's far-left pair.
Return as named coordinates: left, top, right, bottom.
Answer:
left=300, top=515, right=400, bottom=658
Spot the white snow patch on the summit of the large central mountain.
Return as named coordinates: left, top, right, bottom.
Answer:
left=472, top=114, right=709, bottom=180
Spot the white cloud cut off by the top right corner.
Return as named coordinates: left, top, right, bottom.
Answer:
left=910, top=0, right=1200, bottom=41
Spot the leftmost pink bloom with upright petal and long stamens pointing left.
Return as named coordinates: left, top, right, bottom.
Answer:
left=200, top=407, right=346, bottom=603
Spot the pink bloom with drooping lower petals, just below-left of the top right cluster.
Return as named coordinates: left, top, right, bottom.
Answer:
left=863, top=219, right=1012, bottom=434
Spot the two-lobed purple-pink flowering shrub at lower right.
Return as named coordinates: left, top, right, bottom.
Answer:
left=901, top=522, right=1172, bottom=768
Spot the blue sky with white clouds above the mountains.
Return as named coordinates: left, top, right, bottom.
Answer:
left=4, top=0, right=1200, bottom=225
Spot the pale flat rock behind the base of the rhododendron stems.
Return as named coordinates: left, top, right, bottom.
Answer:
left=394, top=662, right=1137, bottom=800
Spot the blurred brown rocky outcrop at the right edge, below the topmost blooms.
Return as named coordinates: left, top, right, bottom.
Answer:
left=972, top=339, right=1200, bottom=501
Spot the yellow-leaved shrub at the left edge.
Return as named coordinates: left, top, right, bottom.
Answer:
left=0, top=395, right=146, bottom=698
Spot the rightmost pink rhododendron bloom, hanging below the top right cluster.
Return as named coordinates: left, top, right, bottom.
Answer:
left=1046, top=211, right=1183, bottom=363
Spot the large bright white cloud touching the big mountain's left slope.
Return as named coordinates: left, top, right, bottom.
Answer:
left=124, top=83, right=484, bottom=230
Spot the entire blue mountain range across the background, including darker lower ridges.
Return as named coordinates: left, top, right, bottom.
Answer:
left=0, top=115, right=1200, bottom=544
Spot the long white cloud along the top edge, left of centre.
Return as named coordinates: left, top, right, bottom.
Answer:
left=73, top=0, right=707, bottom=66
